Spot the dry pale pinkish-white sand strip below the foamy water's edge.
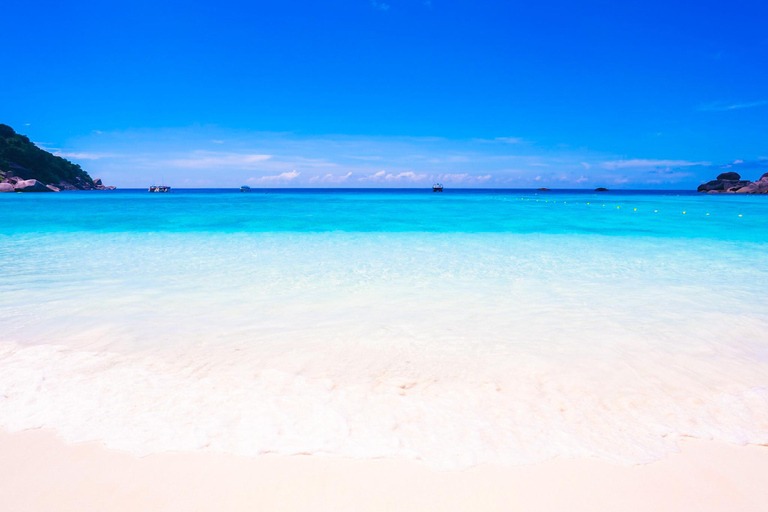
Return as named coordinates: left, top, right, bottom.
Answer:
left=0, top=430, right=768, bottom=512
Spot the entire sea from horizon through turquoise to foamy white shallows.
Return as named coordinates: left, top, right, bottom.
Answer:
left=0, top=189, right=768, bottom=469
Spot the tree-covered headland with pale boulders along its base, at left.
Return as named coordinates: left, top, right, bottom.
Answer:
left=0, top=124, right=115, bottom=192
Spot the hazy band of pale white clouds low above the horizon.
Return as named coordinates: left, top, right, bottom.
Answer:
left=46, top=127, right=768, bottom=189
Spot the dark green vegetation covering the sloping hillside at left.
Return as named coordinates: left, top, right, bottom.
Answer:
left=0, top=124, right=93, bottom=185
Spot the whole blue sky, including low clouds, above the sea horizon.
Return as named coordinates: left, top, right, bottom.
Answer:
left=0, top=0, right=768, bottom=189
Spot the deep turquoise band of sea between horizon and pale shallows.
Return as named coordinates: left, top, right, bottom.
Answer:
left=0, top=189, right=768, bottom=241
